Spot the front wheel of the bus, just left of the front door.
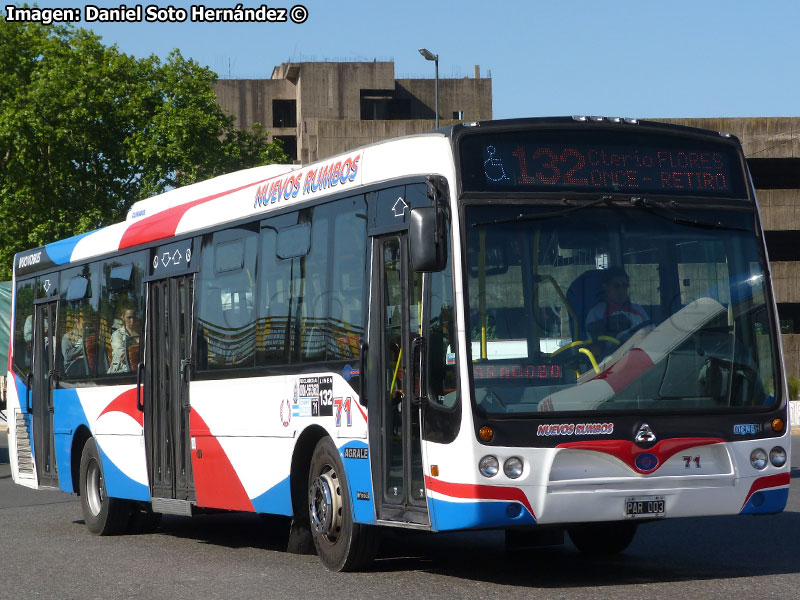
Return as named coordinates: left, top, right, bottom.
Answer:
left=308, top=437, right=379, bottom=571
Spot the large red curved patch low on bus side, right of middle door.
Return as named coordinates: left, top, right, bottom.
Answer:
left=189, top=409, right=256, bottom=512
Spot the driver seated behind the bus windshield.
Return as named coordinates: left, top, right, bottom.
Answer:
left=586, top=267, right=650, bottom=341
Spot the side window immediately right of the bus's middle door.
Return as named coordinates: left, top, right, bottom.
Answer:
left=196, top=227, right=258, bottom=370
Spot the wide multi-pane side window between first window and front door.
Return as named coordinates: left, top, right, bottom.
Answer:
left=256, top=196, right=367, bottom=365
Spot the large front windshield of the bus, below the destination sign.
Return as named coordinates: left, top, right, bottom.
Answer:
left=465, top=203, right=776, bottom=415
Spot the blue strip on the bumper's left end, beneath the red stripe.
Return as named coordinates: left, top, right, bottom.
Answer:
left=428, top=498, right=536, bottom=531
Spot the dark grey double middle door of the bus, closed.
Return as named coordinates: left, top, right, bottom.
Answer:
left=144, top=274, right=195, bottom=514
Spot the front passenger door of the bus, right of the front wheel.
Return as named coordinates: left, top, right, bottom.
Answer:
left=367, top=233, right=430, bottom=526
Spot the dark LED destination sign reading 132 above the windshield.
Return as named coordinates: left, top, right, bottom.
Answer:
left=461, top=131, right=746, bottom=198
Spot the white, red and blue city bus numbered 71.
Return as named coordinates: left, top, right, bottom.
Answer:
left=8, top=117, right=790, bottom=570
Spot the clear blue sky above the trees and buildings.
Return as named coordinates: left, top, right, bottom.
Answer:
left=12, top=0, right=800, bottom=118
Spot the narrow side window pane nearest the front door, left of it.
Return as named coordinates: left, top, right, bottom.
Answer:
left=328, top=196, right=367, bottom=359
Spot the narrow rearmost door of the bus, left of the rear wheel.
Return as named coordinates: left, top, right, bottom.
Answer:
left=31, top=302, right=58, bottom=487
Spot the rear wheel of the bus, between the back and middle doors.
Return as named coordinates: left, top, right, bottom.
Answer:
left=79, top=438, right=133, bottom=535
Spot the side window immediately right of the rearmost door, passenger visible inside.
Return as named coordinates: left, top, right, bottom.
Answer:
left=56, top=263, right=100, bottom=380
